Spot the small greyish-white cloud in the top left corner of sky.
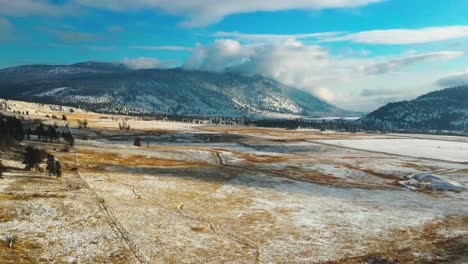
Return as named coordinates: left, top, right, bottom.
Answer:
left=0, top=0, right=77, bottom=17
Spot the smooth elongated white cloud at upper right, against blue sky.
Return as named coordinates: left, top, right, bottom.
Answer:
left=323, top=26, right=468, bottom=45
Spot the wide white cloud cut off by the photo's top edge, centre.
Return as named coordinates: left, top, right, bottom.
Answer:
left=75, top=0, right=383, bottom=27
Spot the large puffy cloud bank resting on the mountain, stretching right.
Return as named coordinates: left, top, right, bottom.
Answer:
left=184, top=39, right=465, bottom=106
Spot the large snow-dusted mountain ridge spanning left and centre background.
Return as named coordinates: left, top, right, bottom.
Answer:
left=0, top=62, right=349, bottom=116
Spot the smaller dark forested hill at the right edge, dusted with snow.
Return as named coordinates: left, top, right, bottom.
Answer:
left=361, top=86, right=468, bottom=130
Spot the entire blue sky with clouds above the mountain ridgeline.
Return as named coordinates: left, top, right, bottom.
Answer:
left=0, top=0, right=468, bottom=111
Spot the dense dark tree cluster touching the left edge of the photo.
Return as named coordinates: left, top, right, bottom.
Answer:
left=0, top=116, right=25, bottom=149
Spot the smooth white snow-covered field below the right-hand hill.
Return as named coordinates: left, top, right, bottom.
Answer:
left=319, top=139, right=468, bottom=162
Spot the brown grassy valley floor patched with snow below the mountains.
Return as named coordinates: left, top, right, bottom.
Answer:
left=0, top=102, right=468, bottom=263
